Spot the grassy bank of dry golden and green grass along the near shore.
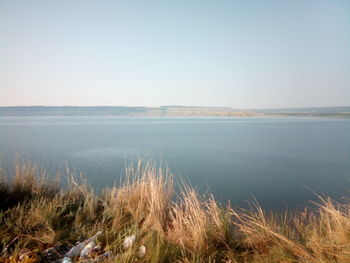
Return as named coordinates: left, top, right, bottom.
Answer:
left=0, top=163, right=350, bottom=263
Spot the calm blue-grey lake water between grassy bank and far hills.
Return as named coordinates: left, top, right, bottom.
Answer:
left=0, top=117, right=350, bottom=210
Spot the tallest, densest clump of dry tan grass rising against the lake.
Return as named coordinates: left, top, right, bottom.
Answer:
left=104, top=161, right=173, bottom=235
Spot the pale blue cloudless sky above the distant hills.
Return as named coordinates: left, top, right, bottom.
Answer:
left=0, top=0, right=350, bottom=109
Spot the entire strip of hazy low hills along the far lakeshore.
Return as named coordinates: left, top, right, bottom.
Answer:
left=0, top=105, right=350, bottom=117
